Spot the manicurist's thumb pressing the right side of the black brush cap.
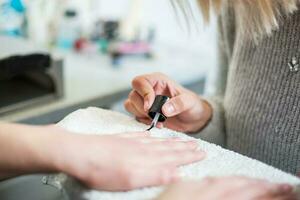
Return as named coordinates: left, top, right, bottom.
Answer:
left=162, top=94, right=195, bottom=117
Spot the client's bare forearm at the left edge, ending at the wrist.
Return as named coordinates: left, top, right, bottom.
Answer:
left=0, top=123, right=66, bottom=177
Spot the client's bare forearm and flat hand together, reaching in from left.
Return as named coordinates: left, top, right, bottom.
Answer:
left=0, top=123, right=204, bottom=191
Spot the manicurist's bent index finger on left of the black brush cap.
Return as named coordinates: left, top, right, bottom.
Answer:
left=132, top=76, right=155, bottom=111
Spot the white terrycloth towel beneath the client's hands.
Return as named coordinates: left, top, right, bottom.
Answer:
left=54, top=108, right=300, bottom=200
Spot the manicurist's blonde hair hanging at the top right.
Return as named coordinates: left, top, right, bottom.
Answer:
left=172, top=0, right=300, bottom=39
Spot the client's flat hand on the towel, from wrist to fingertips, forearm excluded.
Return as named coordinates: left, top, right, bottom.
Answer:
left=58, top=132, right=204, bottom=191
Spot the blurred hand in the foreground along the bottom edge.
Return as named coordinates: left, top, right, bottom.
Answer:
left=157, top=177, right=296, bottom=200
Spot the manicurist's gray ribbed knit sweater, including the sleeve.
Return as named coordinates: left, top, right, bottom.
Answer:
left=199, top=7, right=300, bottom=174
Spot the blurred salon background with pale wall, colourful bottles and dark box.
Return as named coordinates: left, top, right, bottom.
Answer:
left=0, top=0, right=217, bottom=124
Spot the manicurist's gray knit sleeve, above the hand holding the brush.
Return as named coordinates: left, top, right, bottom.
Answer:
left=195, top=7, right=235, bottom=146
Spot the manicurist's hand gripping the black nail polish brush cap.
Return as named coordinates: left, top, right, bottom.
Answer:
left=124, top=73, right=212, bottom=133
